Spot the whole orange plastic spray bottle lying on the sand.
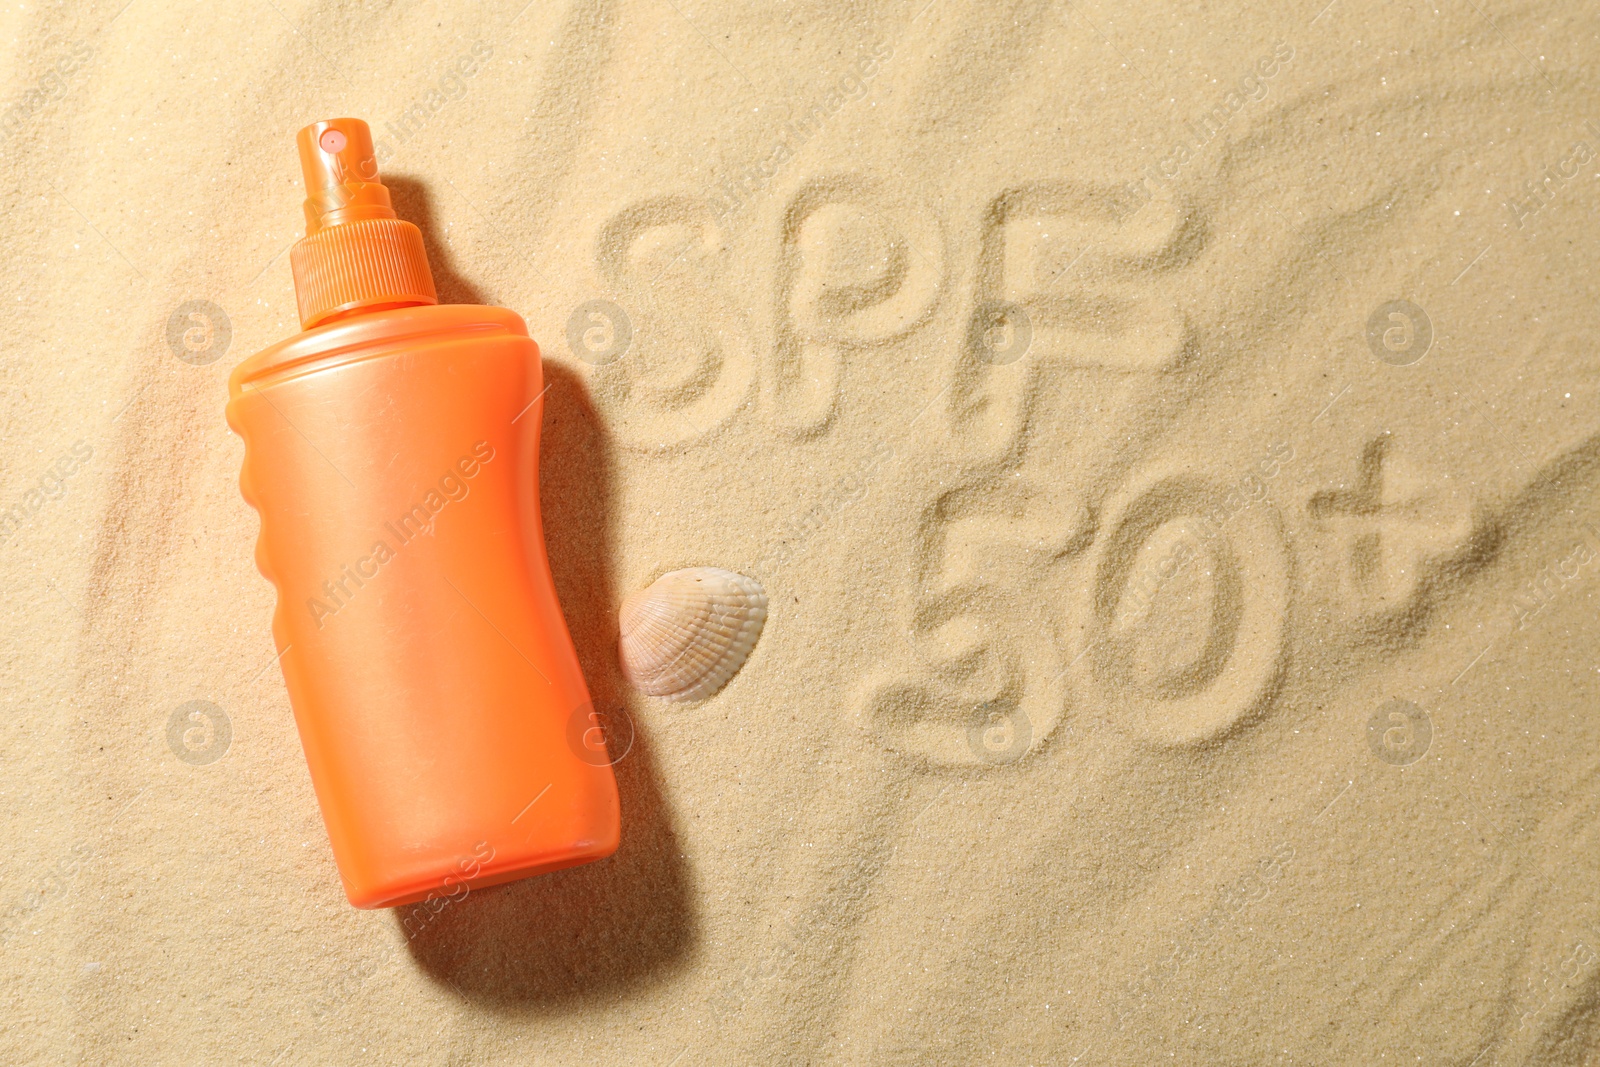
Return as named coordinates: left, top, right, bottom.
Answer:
left=227, top=118, right=619, bottom=907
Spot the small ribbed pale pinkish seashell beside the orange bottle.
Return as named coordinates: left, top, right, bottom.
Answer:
left=618, top=566, right=766, bottom=701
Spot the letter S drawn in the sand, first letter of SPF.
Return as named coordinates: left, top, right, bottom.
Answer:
left=594, top=197, right=755, bottom=451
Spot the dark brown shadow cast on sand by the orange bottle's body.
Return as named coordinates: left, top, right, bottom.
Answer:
left=395, top=355, right=698, bottom=1014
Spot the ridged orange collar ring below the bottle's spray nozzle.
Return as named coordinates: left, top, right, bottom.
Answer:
left=290, top=219, right=438, bottom=330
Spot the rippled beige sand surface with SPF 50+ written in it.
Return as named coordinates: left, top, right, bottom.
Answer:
left=0, top=0, right=1600, bottom=1067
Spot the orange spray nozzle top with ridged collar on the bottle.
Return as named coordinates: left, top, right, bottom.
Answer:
left=290, top=118, right=438, bottom=330
